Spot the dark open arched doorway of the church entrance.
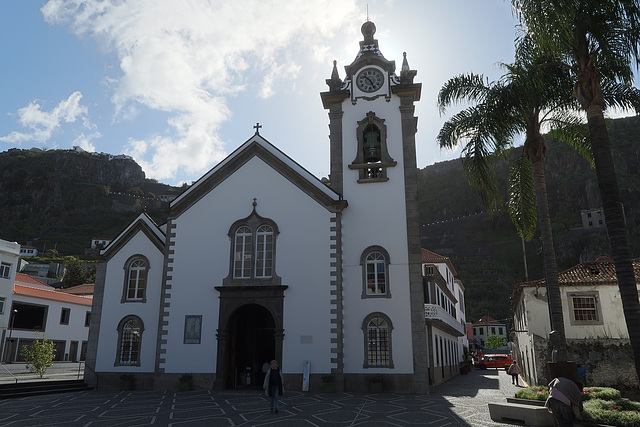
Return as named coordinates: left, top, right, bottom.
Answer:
left=225, top=304, right=276, bottom=388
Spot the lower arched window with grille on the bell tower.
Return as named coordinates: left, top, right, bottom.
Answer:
left=362, top=313, right=393, bottom=368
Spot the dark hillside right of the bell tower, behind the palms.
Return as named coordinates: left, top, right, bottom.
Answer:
left=419, top=117, right=640, bottom=320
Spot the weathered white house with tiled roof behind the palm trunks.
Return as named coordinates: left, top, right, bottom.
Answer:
left=512, top=257, right=640, bottom=388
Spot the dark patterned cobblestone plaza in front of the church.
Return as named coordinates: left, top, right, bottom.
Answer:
left=0, top=369, right=528, bottom=427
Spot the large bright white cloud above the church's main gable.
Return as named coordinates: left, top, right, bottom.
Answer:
left=41, top=0, right=359, bottom=179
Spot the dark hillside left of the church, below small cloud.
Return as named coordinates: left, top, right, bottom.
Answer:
left=0, top=149, right=181, bottom=255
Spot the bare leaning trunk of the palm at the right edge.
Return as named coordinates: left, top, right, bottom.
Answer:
left=587, top=104, right=640, bottom=388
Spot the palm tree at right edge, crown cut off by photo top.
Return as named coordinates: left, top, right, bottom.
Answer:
left=512, top=0, right=640, bottom=386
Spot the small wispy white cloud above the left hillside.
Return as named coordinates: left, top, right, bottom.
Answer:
left=0, top=91, right=92, bottom=144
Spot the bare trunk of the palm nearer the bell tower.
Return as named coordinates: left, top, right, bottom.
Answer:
left=529, top=154, right=567, bottom=354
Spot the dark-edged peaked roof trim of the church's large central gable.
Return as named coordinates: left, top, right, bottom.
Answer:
left=171, top=133, right=347, bottom=217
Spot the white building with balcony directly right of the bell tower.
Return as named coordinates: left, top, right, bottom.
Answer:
left=422, top=249, right=469, bottom=385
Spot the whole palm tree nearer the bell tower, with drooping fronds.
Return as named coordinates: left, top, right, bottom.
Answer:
left=437, top=45, right=588, bottom=360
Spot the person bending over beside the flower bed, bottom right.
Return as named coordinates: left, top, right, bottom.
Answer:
left=544, top=377, right=583, bottom=427
